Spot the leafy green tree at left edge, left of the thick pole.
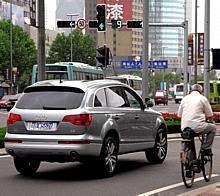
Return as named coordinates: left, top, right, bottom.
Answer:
left=0, top=20, right=37, bottom=90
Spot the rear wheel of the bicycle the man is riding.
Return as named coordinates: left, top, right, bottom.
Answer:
left=181, top=152, right=195, bottom=188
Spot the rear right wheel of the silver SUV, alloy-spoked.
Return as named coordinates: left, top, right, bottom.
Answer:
left=100, top=136, right=118, bottom=177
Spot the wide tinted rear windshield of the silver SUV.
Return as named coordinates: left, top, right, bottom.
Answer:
left=16, top=86, right=85, bottom=110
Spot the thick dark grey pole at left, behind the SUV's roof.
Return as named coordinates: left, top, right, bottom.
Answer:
left=37, top=0, right=45, bottom=81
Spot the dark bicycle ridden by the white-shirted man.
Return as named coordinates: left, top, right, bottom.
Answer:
left=180, top=127, right=212, bottom=188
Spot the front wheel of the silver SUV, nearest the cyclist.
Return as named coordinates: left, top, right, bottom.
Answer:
left=145, top=128, right=167, bottom=163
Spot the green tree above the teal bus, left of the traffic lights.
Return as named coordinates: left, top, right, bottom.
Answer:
left=47, top=29, right=96, bottom=65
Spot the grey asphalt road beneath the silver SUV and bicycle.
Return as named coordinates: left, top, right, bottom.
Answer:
left=0, top=137, right=220, bottom=196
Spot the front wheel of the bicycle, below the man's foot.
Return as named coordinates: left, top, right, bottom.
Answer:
left=201, top=155, right=212, bottom=182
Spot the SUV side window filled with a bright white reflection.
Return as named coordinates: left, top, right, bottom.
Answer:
left=105, top=86, right=128, bottom=108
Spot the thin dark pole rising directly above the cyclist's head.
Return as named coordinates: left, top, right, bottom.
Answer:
left=194, top=0, right=198, bottom=84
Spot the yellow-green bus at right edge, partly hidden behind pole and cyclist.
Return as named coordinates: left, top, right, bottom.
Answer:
left=198, top=80, right=220, bottom=104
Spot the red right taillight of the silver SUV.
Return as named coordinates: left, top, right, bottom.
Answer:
left=62, top=114, right=92, bottom=126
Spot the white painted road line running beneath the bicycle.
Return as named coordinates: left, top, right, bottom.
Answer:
left=138, top=174, right=219, bottom=196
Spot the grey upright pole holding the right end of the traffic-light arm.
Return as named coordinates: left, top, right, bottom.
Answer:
left=183, top=20, right=188, bottom=96
